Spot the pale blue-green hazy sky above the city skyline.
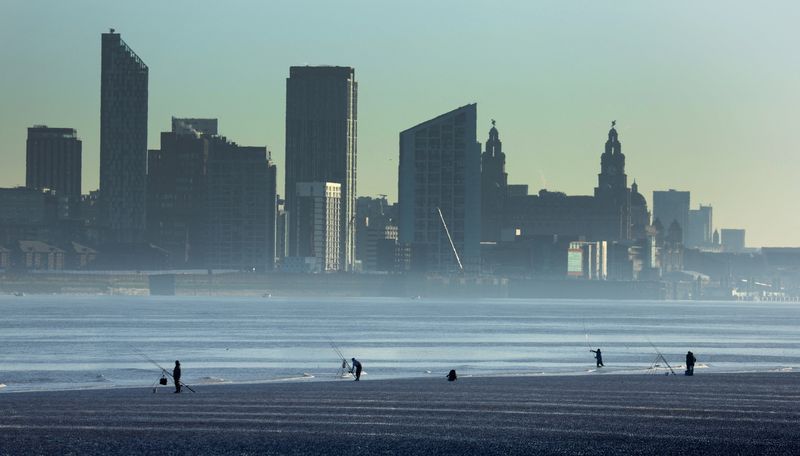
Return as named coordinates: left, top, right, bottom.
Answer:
left=0, top=0, right=800, bottom=246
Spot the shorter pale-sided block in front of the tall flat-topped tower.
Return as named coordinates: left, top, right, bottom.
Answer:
left=291, top=182, right=342, bottom=272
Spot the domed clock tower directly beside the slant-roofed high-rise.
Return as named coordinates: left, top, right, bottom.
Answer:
left=481, top=119, right=508, bottom=241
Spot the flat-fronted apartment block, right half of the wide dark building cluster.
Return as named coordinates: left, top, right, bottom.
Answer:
left=205, top=136, right=277, bottom=271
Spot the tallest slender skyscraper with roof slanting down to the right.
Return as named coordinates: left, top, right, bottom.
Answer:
left=100, top=29, right=148, bottom=243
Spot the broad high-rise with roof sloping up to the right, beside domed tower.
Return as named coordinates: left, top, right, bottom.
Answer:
left=398, top=104, right=481, bottom=272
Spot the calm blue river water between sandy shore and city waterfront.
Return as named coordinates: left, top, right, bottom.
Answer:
left=0, top=296, right=800, bottom=392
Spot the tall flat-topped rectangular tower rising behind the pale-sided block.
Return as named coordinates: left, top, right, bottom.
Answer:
left=285, top=66, right=358, bottom=271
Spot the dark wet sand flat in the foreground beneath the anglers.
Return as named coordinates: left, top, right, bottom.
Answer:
left=0, top=373, right=800, bottom=455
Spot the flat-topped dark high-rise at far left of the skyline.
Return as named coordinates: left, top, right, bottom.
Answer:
left=25, top=125, right=81, bottom=202
